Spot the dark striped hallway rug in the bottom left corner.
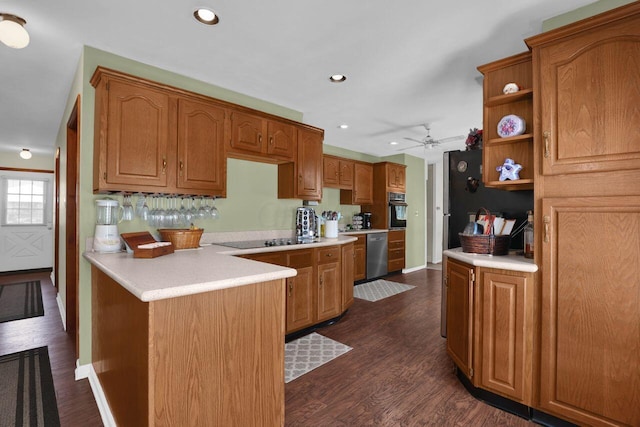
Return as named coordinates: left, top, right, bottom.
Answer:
left=0, top=347, right=60, bottom=427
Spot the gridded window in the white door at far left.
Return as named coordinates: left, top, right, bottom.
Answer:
left=2, top=177, right=48, bottom=225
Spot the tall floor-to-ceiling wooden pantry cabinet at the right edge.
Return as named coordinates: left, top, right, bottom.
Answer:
left=526, top=2, right=640, bottom=426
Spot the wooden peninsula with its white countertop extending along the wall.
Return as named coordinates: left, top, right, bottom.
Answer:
left=84, top=236, right=356, bottom=426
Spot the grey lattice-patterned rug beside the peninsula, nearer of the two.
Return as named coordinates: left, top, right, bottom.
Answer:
left=284, top=332, right=353, bottom=383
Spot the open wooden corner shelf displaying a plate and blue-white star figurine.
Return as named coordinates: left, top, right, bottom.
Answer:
left=478, top=52, right=534, bottom=190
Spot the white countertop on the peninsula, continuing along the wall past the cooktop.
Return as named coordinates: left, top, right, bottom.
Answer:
left=83, top=236, right=356, bottom=302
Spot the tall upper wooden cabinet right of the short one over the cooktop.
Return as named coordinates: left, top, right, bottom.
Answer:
left=278, top=128, right=324, bottom=200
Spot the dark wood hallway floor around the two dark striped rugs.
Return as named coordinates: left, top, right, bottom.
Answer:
left=0, top=272, right=102, bottom=427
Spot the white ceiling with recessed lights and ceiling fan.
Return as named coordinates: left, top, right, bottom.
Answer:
left=0, top=0, right=593, bottom=163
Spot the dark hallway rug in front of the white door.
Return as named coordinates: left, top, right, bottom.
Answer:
left=0, top=280, right=44, bottom=323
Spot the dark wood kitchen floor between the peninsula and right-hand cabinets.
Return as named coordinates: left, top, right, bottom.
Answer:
left=285, top=269, right=535, bottom=427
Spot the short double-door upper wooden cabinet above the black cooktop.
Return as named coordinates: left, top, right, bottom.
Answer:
left=227, top=111, right=297, bottom=162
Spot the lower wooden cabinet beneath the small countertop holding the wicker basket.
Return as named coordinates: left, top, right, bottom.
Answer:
left=445, top=258, right=534, bottom=406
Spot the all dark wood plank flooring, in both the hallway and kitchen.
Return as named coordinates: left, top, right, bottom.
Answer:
left=0, top=269, right=534, bottom=427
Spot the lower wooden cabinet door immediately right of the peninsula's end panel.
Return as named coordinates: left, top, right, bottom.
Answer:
left=286, top=267, right=314, bottom=333
